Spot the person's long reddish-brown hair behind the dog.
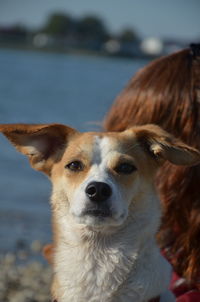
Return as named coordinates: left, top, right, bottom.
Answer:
left=104, top=49, right=200, bottom=286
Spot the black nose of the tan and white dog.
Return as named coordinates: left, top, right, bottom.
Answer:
left=85, top=181, right=112, bottom=202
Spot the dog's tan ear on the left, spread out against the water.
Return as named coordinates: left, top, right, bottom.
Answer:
left=0, top=124, right=78, bottom=174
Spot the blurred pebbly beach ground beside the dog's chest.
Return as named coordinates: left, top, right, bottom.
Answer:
left=0, top=241, right=52, bottom=302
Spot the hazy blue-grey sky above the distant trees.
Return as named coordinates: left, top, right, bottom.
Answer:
left=0, top=0, right=200, bottom=41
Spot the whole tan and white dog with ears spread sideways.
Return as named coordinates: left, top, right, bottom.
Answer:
left=0, top=124, right=200, bottom=302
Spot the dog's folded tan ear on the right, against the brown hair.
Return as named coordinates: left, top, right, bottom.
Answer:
left=132, top=125, right=200, bottom=166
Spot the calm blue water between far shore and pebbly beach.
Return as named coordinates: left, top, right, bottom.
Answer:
left=0, top=49, right=145, bottom=250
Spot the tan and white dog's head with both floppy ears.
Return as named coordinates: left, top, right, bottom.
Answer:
left=0, top=124, right=200, bottom=228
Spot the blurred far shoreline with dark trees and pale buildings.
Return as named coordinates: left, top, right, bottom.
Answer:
left=0, top=12, right=189, bottom=57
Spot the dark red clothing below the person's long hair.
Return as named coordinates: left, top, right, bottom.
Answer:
left=170, top=273, right=200, bottom=302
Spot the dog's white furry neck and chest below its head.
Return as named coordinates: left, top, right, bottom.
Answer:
left=52, top=190, right=168, bottom=302
